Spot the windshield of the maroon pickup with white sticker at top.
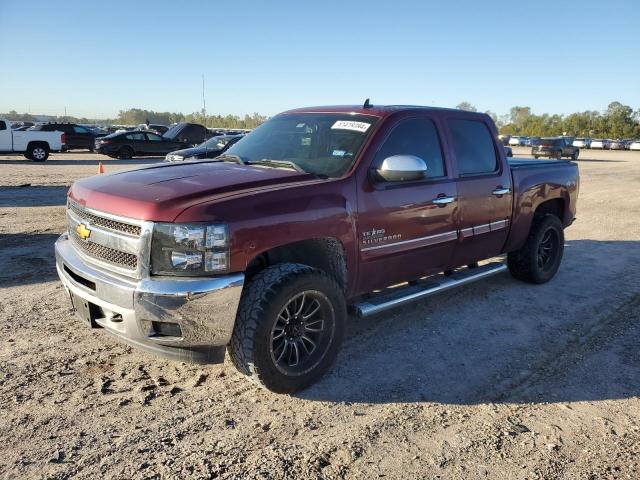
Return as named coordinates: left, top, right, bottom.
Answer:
left=225, top=113, right=377, bottom=178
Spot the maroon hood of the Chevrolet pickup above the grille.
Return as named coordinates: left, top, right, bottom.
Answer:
left=69, top=161, right=316, bottom=222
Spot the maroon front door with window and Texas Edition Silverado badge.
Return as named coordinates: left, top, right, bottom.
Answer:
left=357, top=113, right=458, bottom=293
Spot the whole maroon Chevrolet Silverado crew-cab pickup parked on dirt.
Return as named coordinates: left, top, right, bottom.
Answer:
left=55, top=102, right=579, bottom=392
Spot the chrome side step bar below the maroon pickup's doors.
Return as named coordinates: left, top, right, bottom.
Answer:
left=351, top=262, right=507, bottom=317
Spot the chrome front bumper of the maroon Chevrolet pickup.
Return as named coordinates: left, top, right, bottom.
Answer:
left=55, top=234, right=244, bottom=363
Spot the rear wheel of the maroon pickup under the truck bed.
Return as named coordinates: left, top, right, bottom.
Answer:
left=507, top=214, right=564, bottom=283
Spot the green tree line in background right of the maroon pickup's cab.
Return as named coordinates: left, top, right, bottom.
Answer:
left=457, top=102, right=640, bottom=138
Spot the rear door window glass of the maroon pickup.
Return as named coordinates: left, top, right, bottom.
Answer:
left=447, top=119, right=498, bottom=175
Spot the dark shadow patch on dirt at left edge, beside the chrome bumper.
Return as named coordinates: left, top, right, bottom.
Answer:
left=0, top=233, right=59, bottom=287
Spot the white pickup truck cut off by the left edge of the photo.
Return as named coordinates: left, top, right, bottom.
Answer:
left=0, top=118, right=65, bottom=162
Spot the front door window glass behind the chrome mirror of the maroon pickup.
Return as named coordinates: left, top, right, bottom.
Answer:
left=374, top=118, right=446, bottom=178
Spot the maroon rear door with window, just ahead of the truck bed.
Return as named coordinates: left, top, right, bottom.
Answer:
left=445, top=113, right=513, bottom=266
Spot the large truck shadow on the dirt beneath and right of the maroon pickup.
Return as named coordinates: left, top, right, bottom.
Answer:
left=298, top=240, right=640, bottom=404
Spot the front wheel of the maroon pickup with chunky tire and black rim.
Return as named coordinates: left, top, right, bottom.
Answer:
left=228, top=263, right=347, bottom=393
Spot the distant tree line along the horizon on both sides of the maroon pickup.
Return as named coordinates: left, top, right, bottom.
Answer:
left=3, top=102, right=640, bottom=138
